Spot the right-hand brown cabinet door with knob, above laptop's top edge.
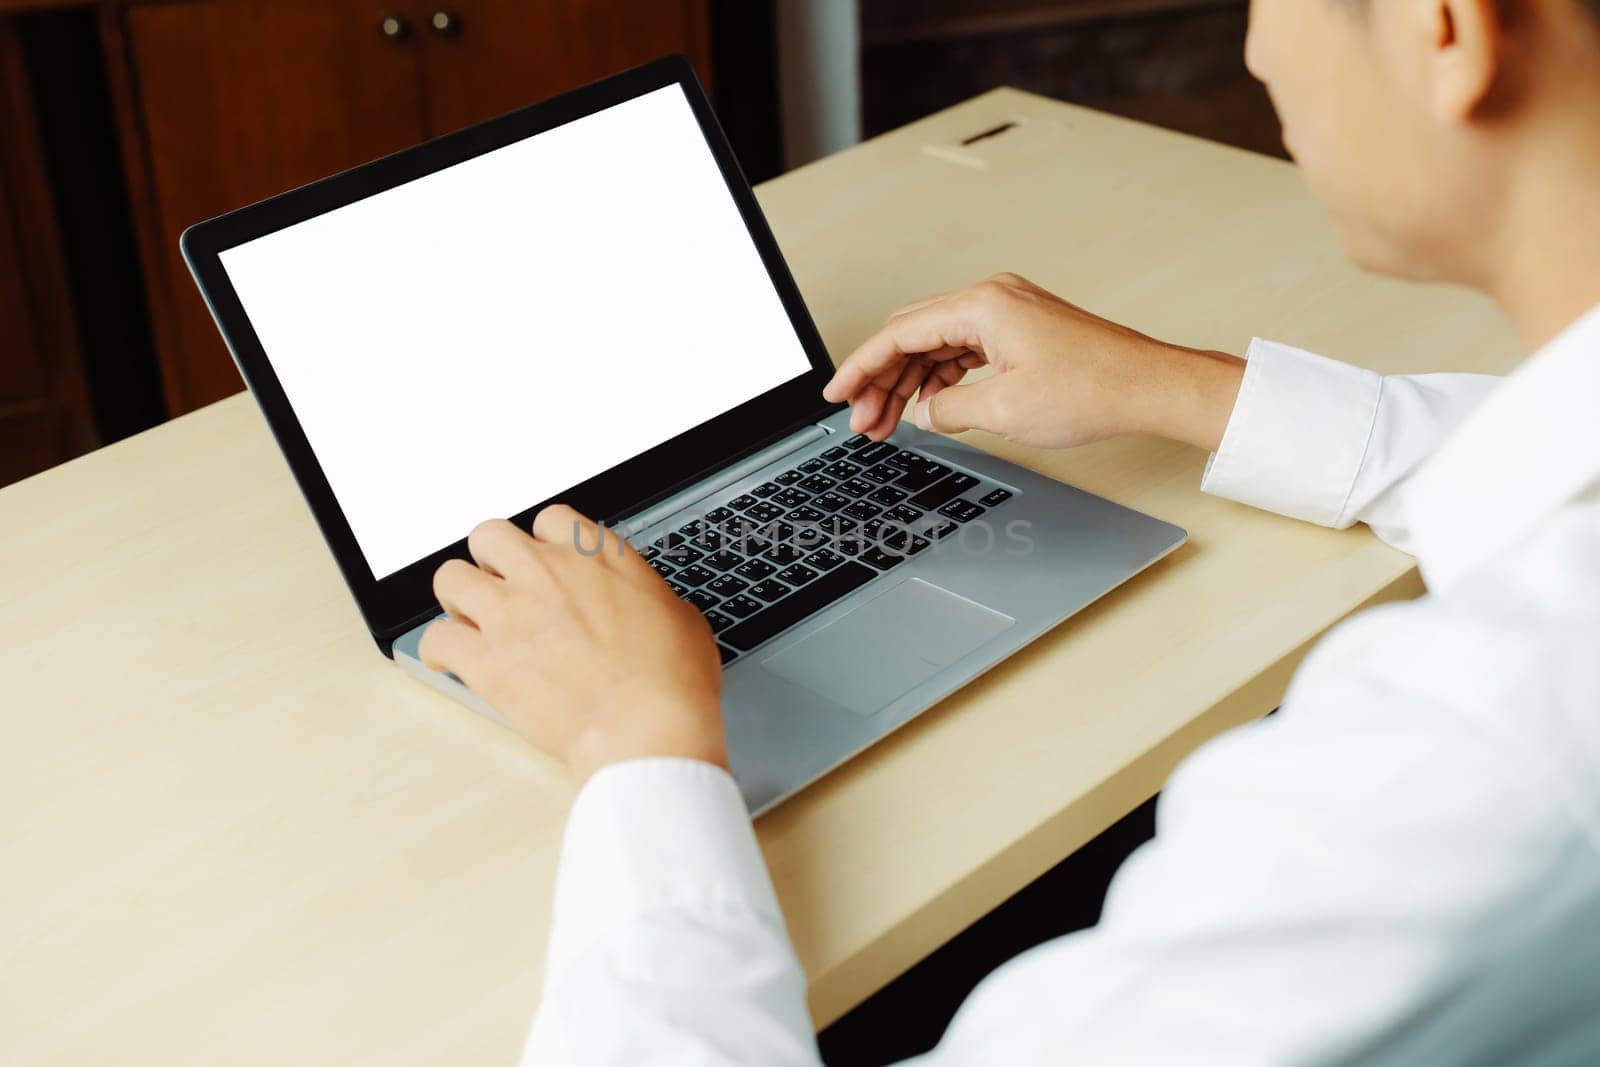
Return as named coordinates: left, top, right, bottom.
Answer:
left=413, top=0, right=710, bottom=136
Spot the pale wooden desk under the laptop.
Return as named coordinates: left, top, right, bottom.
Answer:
left=0, top=90, right=1514, bottom=1067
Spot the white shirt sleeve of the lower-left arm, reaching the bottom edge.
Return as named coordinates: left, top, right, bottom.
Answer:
left=522, top=758, right=819, bottom=1067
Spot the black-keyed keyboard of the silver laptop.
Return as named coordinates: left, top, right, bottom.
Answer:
left=624, top=434, right=1011, bottom=664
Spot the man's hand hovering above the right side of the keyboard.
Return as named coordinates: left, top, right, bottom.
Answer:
left=822, top=274, right=1245, bottom=451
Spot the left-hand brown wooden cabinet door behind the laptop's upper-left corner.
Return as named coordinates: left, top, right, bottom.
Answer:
left=112, top=0, right=424, bottom=414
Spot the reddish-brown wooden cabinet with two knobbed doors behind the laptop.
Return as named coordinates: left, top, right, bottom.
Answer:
left=104, top=0, right=707, bottom=414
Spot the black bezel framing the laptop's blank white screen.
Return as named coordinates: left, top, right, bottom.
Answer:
left=179, top=54, right=838, bottom=656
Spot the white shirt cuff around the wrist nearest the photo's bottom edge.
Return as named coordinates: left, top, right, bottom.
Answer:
left=546, top=757, right=782, bottom=982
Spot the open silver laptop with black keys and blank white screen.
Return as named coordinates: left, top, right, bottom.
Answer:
left=182, top=56, right=1184, bottom=814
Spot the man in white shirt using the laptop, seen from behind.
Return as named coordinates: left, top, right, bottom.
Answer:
left=422, top=0, right=1600, bottom=1065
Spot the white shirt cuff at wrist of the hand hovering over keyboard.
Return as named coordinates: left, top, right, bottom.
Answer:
left=1200, top=338, right=1382, bottom=526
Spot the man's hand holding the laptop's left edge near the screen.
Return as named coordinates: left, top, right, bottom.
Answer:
left=419, top=506, right=728, bottom=784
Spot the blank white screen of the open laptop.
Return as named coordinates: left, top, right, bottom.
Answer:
left=221, top=85, right=810, bottom=577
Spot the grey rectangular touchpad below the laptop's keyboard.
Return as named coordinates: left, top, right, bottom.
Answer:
left=762, top=577, right=1016, bottom=715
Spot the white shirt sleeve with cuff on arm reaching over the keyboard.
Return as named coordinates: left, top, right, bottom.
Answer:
left=1200, top=338, right=1501, bottom=550
